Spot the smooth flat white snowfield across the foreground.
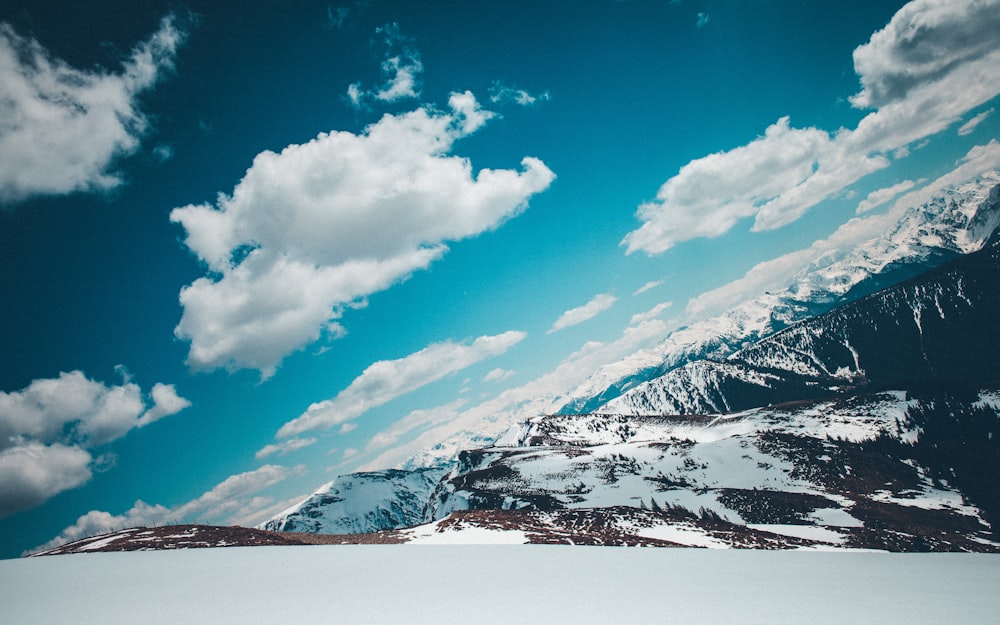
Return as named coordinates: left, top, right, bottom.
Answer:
left=0, top=545, right=1000, bottom=625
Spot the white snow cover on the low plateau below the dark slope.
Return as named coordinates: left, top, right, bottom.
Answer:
left=431, top=391, right=980, bottom=528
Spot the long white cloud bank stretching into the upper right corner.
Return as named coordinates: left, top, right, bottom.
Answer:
left=622, top=0, right=1000, bottom=254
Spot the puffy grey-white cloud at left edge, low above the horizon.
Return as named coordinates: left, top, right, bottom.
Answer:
left=0, top=371, right=191, bottom=517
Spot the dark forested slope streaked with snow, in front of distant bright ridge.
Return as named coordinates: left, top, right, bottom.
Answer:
left=602, top=236, right=1000, bottom=414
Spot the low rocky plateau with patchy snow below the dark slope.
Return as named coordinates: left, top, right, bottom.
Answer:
left=430, top=390, right=1000, bottom=551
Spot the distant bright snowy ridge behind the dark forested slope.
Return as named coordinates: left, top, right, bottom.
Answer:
left=559, top=171, right=1000, bottom=413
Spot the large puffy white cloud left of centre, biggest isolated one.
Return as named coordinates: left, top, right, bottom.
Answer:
left=171, top=92, right=555, bottom=378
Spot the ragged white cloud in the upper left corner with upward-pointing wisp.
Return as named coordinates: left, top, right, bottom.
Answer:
left=0, top=17, right=184, bottom=203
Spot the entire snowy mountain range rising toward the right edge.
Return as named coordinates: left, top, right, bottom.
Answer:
left=261, top=172, right=1000, bottom=551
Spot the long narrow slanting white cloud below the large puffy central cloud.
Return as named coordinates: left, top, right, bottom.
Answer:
left=278, top=331, right=526, bottom=437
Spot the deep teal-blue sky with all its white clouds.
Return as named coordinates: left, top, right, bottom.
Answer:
left=0, top=0, right=1000, bottom=557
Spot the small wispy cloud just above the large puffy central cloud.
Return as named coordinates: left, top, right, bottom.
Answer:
left=347, top=23, right=424, bottom=108
